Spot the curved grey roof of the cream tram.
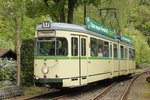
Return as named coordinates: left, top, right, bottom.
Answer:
left=36, top=22, right=134, bottom=45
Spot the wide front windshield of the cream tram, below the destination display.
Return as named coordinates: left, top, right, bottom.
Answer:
left=35, top=37, right=68, bottom=56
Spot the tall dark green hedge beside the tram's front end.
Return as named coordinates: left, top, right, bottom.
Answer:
left=21, top=39, right=34, bottom=86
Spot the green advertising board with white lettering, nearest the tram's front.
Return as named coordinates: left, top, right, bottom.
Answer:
left=86, top=17, right=115, bottom=38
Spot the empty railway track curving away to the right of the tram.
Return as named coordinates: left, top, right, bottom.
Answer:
left=90, top=71, right=150, bottom=100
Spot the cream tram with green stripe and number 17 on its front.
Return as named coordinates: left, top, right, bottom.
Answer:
left=34, top=18, right=135, bottom=87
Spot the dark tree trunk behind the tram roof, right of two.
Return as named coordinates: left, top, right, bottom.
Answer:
left=67, top=0, right=77, bottom=23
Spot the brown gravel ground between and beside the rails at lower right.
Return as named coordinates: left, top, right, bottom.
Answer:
left=54, top=73, right=150, bottom=100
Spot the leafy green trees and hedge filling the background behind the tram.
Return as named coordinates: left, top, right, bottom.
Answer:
left=0, top=0, right=150, bottom=85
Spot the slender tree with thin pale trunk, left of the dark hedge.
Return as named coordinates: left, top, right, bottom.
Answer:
left=1, top=0, right=25, bottom=85
